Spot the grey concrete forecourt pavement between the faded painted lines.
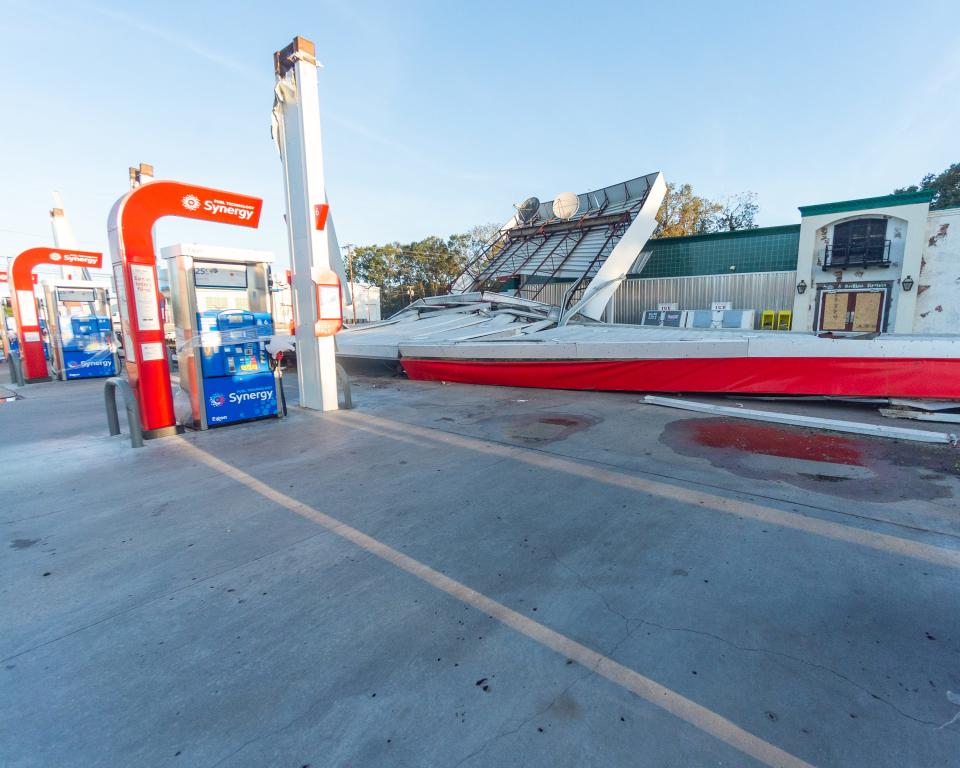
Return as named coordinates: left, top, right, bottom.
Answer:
left=0, top=368, right=960, bottom=768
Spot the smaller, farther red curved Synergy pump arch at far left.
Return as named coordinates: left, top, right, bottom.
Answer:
left=3, top=248, right=103, bottom=382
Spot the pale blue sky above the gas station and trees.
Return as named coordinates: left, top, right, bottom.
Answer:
left=0, top=0, right=960, bottom=270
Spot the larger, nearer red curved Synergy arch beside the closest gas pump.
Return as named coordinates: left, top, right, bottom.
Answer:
left=108, top=181, right=263, bottom=438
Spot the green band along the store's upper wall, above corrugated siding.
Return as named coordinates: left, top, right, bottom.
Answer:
left=631, top=224, right=800, bottom=278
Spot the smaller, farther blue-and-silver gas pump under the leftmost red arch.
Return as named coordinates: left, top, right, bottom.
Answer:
left=40, top=280, right=120, bottom=381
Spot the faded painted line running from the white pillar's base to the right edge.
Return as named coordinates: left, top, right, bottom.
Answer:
left=341, top=411, right=960, bottom=568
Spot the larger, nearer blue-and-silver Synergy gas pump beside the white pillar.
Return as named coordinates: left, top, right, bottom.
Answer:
left=160, top=243, right=280, bottom=429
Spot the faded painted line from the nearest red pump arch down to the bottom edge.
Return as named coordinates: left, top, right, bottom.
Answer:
left=179, top=438, right=813, bottom=768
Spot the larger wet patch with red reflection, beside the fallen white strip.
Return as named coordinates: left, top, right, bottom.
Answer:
left=660, top=418, right=960, bottom=503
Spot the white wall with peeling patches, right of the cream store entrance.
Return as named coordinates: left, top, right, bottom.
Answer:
left=913, top=208, right=960, bottom=334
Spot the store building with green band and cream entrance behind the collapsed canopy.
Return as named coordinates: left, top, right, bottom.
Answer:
left=592, top=191, right=960, bottom=335
